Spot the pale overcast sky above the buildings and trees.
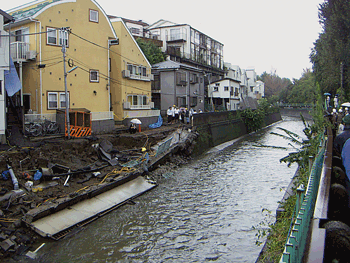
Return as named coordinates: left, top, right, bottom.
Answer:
left=0, top=0, right=324, bottom=79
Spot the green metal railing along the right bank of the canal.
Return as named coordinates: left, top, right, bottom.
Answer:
left=280, top=138, right=325, bottom=263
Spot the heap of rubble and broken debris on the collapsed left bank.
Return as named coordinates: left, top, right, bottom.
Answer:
left=0, top=126, right=194, bottom=259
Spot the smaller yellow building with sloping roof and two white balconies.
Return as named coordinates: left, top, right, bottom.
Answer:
left=110, top=18, right=159, bottom=125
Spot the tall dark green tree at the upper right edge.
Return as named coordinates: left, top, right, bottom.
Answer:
left=310, top=0, right=350, bottom=101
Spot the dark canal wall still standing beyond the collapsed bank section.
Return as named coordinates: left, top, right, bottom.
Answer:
left=193, top=111, right=282, bottom=155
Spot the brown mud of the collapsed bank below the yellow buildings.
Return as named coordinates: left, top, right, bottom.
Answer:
left=0, top=125, right=188, bottom=260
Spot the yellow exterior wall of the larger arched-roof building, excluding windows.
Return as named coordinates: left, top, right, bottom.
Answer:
left=7, top=0, right=116, bottom=113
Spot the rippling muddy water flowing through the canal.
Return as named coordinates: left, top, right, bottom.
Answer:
left=33, top=118, right=303, bottom=262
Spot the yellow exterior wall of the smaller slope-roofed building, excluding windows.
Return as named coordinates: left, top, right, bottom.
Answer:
left=110, top=19, right=153, bottom=120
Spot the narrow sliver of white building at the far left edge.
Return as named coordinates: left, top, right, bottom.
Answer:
left=0, top=9, right=13, bottom=144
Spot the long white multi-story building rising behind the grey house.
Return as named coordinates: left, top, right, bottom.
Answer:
left=148, top=19, right=224, bottom=78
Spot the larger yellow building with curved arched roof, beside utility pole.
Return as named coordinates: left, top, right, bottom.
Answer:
left=7, top=0, right=118, bottom=134
